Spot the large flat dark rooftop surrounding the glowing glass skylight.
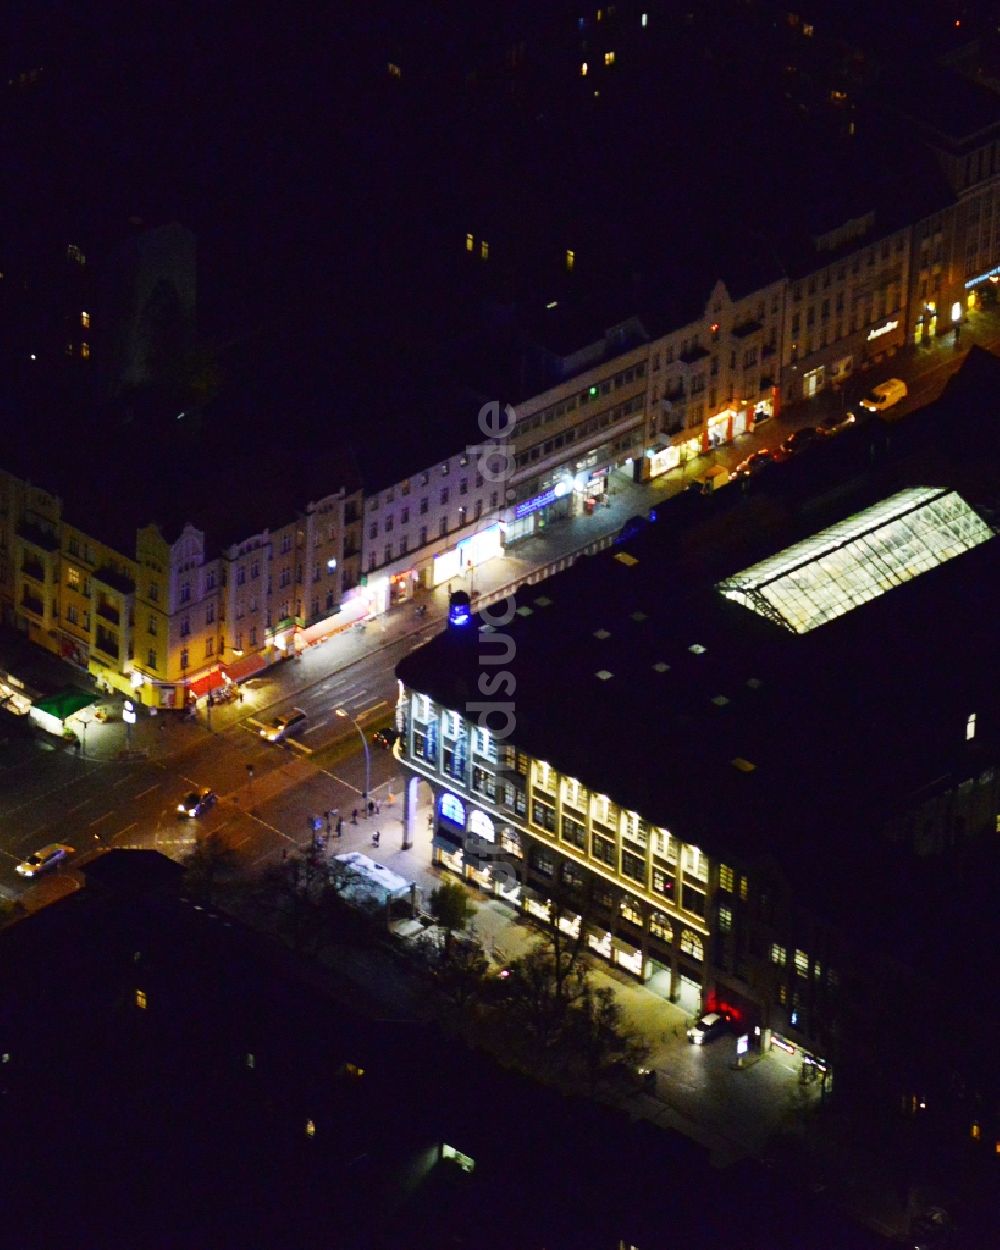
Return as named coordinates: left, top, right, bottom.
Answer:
left=396, top=347, right=1000, bottom=915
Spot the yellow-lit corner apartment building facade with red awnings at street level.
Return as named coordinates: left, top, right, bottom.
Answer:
left=0, top=473, right=361, bottom=709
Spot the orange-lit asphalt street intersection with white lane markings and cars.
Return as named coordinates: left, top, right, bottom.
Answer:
left=0, top=635, right=417, bottom=905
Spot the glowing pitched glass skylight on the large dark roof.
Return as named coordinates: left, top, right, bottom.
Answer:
left=716, top=486, right=994, bottom=634
